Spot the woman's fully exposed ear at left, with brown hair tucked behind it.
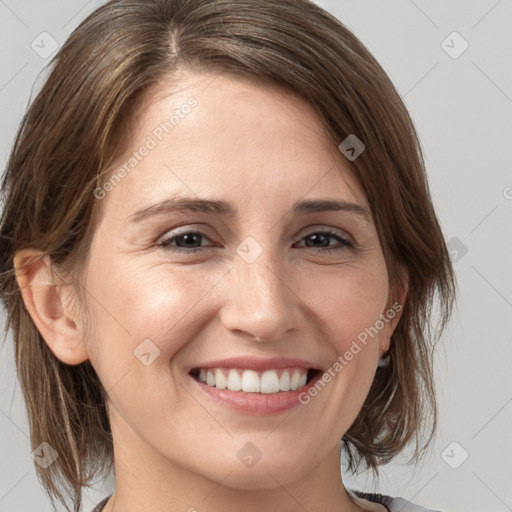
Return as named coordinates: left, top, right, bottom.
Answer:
left=14, top=249, right=89, bottom=365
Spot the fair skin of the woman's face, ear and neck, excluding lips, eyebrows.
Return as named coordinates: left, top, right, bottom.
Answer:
left=15, top=72, right=403, bottom=512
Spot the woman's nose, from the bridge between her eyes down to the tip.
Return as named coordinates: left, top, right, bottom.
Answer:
left=222, top=233, right=296, bottom=341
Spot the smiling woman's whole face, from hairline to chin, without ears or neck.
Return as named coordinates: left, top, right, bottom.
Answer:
left=79, top=73, right=392, bottom=488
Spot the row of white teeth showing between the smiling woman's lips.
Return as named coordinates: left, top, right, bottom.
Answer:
left=190, top=368, right=320, bottom=394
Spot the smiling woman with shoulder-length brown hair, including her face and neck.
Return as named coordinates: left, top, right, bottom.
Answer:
left=1, top=0, right=455, bottom=512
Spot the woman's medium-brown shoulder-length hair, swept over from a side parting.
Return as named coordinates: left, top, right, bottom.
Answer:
left=0, top=0, right=455, bottom=511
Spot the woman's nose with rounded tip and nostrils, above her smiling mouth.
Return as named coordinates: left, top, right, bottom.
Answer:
left=220, top=243, right=301, bottom=342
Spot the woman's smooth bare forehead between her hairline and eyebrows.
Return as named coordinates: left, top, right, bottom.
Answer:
left=99, top=68, right=365, bottom=218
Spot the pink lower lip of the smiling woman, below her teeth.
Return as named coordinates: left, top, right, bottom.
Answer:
left=189, top=372, right=321, bottom=416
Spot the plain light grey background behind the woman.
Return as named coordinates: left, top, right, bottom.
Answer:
left=0, top=0, right=512, bottom=512
